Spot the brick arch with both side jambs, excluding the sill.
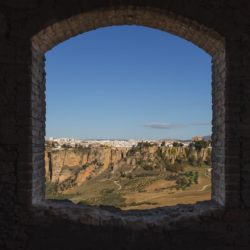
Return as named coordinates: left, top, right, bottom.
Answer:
left=30, top=7, right=227, bottom=209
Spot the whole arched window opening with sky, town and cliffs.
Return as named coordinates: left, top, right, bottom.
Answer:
left=45, top=26, right=212, bottom=210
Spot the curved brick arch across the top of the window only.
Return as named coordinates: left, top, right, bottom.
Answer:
left=32, top=6, right=224, bottom=56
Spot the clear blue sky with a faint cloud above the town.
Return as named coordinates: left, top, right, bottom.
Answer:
left=46, top=26, right=212, bottom=139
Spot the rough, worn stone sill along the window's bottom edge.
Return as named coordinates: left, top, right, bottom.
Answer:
left=33, top=200, right=224, bottom=230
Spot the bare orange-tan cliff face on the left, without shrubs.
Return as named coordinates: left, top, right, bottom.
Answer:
left=45, top=146, right=127, bottom=190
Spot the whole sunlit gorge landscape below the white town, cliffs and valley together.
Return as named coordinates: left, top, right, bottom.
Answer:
left=45, top=141, right=211, bottom=209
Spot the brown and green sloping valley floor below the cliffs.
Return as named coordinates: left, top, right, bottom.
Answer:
left=47, top=166, right=211, bottom=210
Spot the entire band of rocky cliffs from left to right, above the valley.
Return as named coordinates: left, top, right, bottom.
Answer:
left=45, top=144, right=211, bottom=192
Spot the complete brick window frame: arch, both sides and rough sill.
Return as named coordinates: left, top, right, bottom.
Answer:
left=23, top=6, right=234, bottom=224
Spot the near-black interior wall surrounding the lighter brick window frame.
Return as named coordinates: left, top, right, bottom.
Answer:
left=0, top=0, right=250, bottom=250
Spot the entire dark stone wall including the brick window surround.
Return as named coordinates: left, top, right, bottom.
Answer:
left=0, top=0, right=250, bottom=249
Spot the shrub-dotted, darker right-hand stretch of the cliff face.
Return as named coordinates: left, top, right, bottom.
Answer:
left=113, top=144, right=211, bottom=177
